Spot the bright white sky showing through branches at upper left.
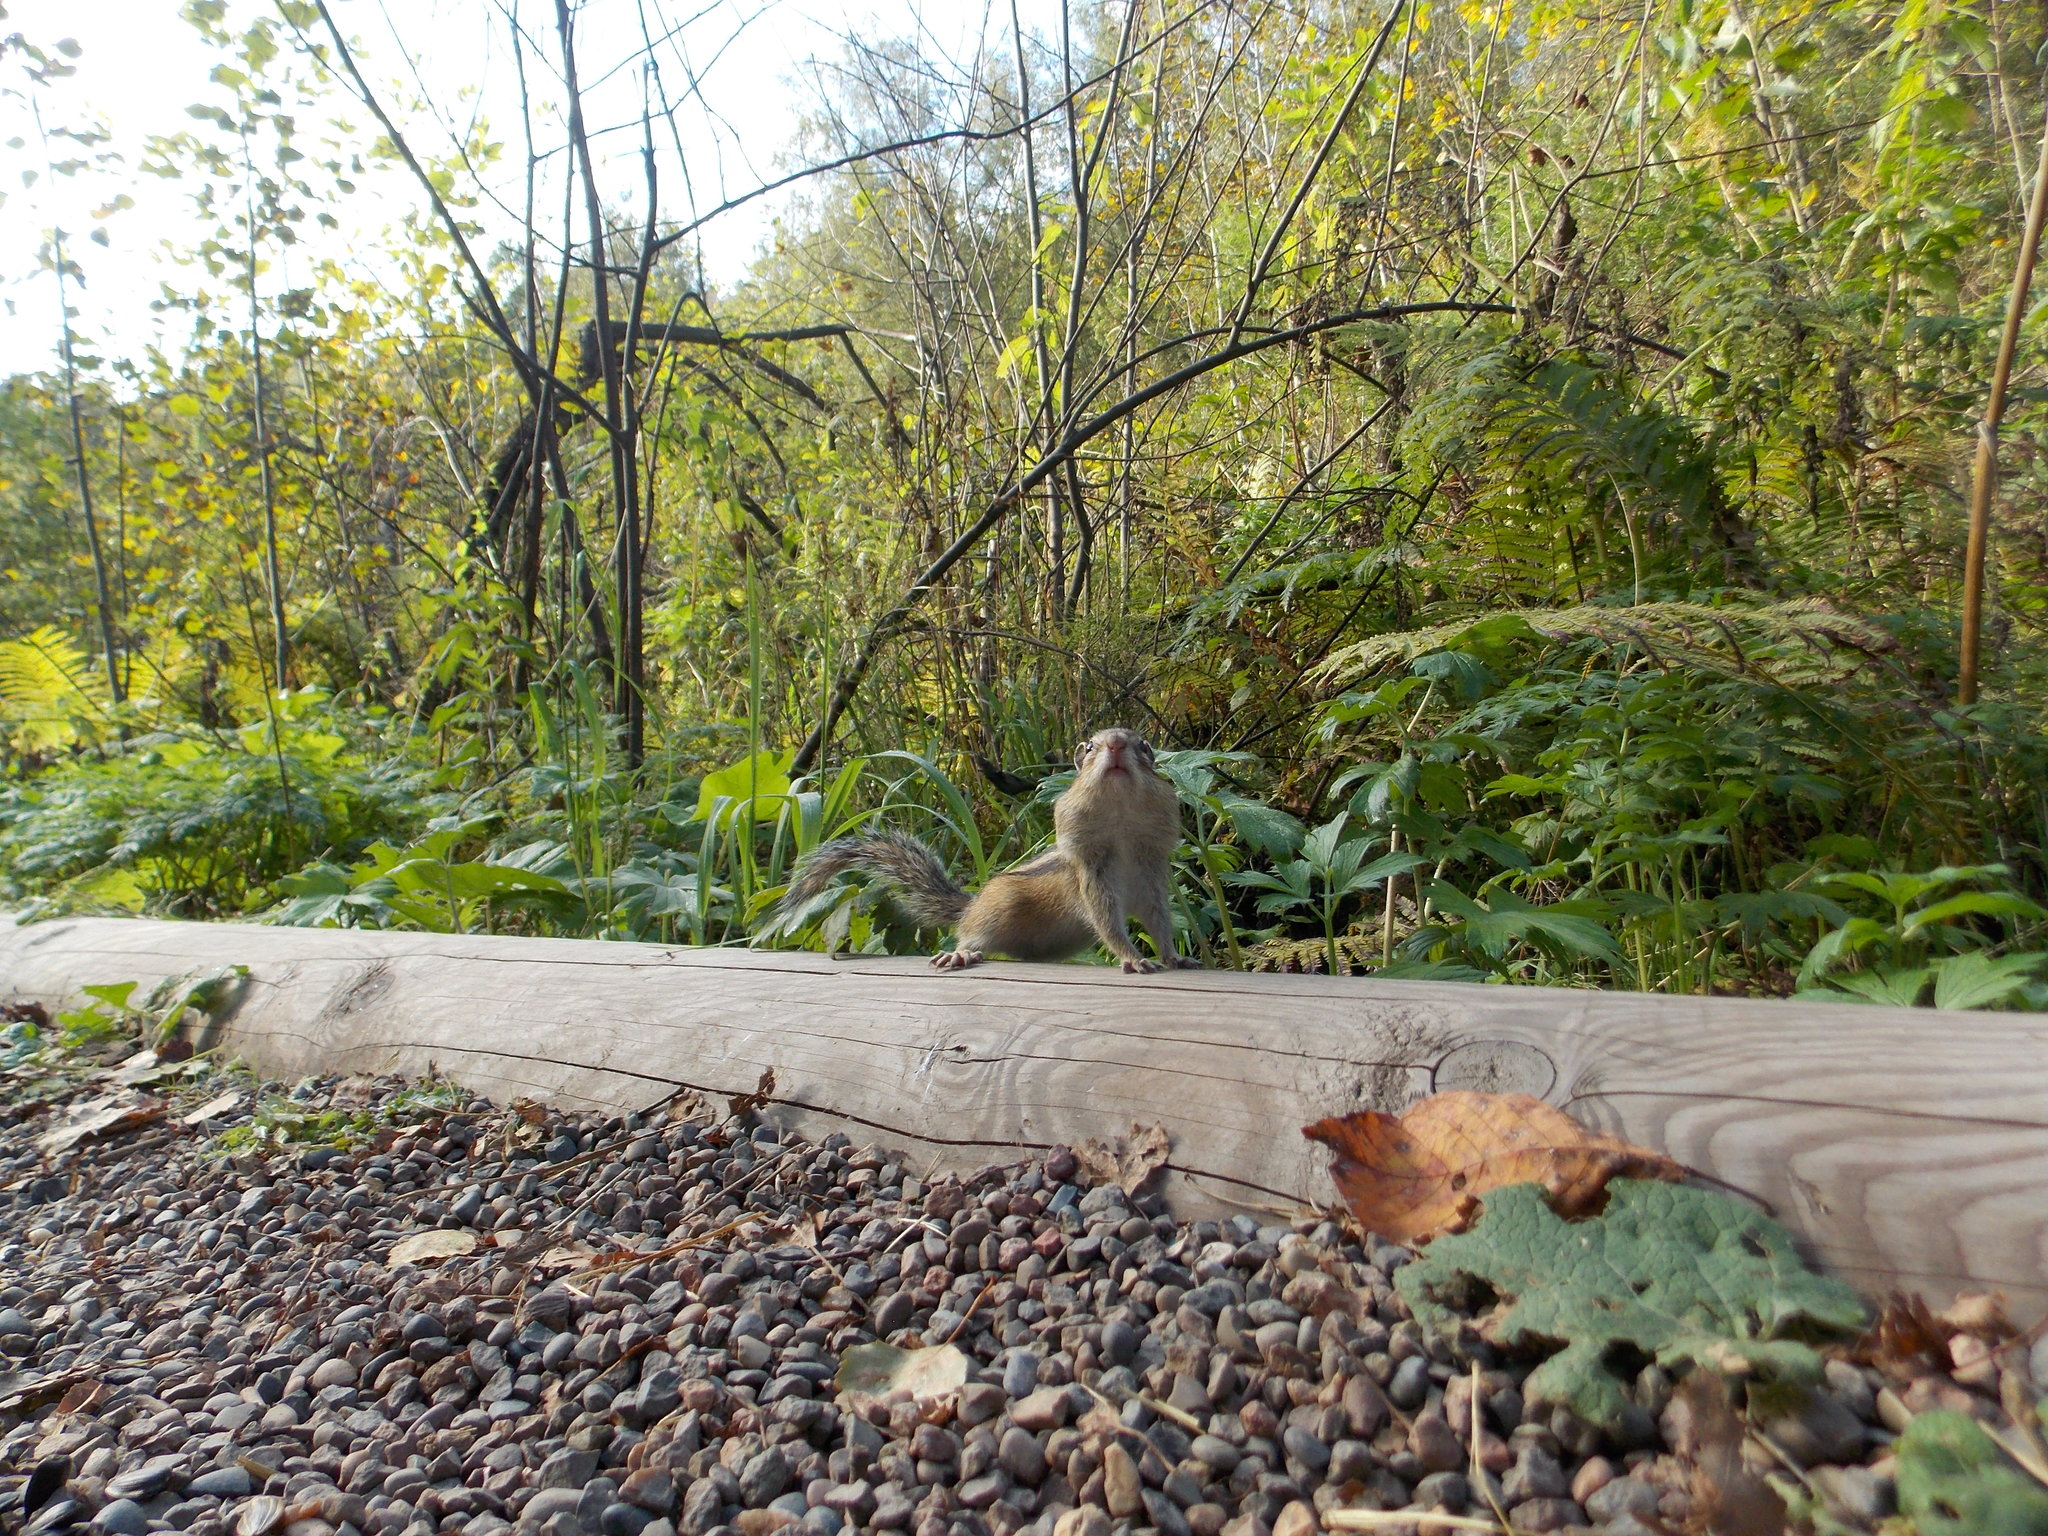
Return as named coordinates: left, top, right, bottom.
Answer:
left=0, top=0, right=1024, bottom=373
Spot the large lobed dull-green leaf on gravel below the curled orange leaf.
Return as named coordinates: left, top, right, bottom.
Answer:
left=1395, top=1180, right=1864, bottom=1430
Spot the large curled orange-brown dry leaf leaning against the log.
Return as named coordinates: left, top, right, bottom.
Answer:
left=1303, top=1092, right=1686, bottom=1243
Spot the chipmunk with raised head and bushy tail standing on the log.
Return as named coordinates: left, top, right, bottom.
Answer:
left=782, top=727, right=1200, bottom=973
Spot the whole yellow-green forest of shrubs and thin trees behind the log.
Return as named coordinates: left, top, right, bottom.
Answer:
left=0, top=0, right=2048, bottom=1008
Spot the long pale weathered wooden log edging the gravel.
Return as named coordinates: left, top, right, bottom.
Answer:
left=0, top=920, right=2048, bottom=1317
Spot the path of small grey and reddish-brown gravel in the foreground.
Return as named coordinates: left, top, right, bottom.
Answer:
left=0, top=1036, right=2023, bottom=1536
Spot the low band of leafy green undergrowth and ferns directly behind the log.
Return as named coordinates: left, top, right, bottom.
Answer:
left=0, top=625, right=2048, bottom=1010
